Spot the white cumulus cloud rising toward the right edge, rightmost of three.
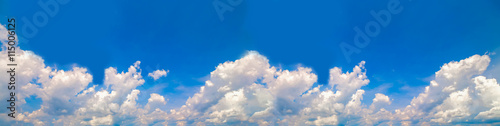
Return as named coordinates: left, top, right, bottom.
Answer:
left=396, top=55, right=500, bottom=124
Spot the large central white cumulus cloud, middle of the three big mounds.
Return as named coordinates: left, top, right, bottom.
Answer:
left=164, top=51, right=390, bottom=125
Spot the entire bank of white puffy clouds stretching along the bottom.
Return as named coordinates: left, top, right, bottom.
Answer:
left=0, top=26, right=500, bottom=125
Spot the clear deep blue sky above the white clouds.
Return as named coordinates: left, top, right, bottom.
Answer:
left=0, top=0, right=500, bottom=124
